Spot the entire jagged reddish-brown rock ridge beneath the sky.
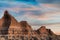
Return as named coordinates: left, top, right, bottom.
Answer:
left=0, top=10, right=60, bottom=40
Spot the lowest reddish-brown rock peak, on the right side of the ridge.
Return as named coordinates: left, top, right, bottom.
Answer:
left=36, top=26, right=58, bottom=40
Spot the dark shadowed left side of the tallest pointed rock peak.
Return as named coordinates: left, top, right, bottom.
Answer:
left=0, top=11, right=11, bottom=35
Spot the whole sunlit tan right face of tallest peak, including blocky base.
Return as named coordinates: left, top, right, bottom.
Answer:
left=8, top=12, right=22, bottom=35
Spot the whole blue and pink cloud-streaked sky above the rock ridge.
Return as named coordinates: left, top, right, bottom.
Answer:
left=0, top=0, right=60, bottom=34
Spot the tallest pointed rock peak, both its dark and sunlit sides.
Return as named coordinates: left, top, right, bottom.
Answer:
left=0, top=11, right=21, bottom=35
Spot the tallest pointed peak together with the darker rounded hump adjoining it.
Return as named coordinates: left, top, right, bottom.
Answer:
left=0, top=11, right=32, bottom=35
